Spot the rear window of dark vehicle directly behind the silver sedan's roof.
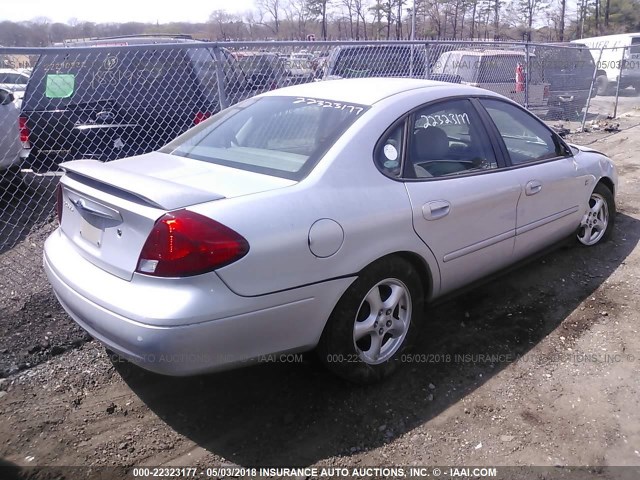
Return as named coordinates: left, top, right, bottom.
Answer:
left=330, top=45, right=425, bottom=78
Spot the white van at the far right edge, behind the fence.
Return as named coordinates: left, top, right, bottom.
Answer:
left=572, top=33, right=640, bottom=95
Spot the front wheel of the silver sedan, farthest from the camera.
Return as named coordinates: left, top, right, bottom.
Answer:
left=577, top=183, right=616, bottom=247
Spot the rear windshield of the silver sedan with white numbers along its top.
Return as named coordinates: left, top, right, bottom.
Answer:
left=160, top=97, right=367, bottom=180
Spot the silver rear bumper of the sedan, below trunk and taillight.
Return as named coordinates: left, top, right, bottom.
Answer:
left=44, top=230, right=352, bottom=376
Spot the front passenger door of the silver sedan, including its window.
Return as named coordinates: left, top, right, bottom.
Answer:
left=480, top=99, right=593, bottom=259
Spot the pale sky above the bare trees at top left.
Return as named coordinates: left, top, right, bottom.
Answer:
left=0, top=0, right=253, bottom=23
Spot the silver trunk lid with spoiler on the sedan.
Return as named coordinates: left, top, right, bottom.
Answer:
left=60, top=152, right=296, bottom=280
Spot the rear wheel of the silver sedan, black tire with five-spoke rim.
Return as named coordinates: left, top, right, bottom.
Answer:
left=317, top=257, right=424, bottom=384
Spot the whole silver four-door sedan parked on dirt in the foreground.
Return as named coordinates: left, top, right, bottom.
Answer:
left=44, top=78, right=617, bottom=382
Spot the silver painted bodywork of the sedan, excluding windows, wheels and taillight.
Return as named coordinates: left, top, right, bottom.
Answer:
left=45, top=79, right=617, bottom=375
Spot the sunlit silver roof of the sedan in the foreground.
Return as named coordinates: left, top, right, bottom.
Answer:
left=263, top=77, right=500, bottom=105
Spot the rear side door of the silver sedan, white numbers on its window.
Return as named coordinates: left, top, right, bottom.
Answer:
left=398, top=98, right=520, bottom=293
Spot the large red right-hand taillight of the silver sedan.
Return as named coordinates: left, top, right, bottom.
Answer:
left=136, top=210, right=249, bottom=277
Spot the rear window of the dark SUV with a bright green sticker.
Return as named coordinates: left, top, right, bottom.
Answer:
left=25, top=48, right=216, bottom=109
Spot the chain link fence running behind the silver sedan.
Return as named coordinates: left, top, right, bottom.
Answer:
left=0, top=37, right=640, bottom=291
